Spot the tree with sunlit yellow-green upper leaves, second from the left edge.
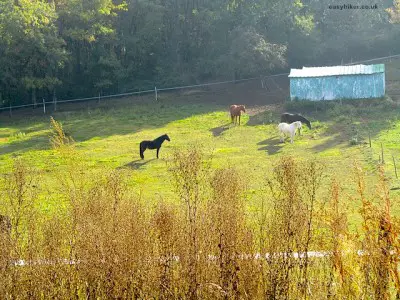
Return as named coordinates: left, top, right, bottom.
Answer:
left=54, top=0, right=125, bottom=96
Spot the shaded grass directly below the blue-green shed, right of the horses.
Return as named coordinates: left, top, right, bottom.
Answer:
left=285, top=99, right=399, bottom=152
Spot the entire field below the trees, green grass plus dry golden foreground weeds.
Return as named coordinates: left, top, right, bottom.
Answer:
left=0, top=85, right=400, bottom=299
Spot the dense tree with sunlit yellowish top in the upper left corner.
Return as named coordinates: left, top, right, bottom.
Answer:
left=0, top=0, right=67, bottom=105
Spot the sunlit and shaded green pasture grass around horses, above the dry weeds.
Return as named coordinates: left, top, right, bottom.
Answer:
left=0, top=96, right=400, bottom=223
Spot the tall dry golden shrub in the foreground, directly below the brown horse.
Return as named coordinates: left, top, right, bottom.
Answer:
left=206, top=169, right=257, bottom=299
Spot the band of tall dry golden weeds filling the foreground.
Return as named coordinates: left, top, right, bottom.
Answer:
left=0, top=148, right=400, bottom=299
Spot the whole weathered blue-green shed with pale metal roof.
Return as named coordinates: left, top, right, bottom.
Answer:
left=289, top=64, right=385, bottom=101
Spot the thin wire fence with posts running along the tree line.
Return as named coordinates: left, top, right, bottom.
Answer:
left=0, top=54, right=400, bottom=114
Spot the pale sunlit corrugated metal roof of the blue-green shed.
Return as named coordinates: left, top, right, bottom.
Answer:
left=289, top=64, right=385, bottom=77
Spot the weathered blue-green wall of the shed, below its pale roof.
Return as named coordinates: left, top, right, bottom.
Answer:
left=290, top=73, right=385, bottom=101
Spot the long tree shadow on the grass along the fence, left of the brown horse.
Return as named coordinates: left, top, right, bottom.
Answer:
left=0, top=82, right=278, bottom=155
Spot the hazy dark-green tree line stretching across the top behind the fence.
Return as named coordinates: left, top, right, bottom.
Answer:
left=0, top=0, right=400, bottom=106
